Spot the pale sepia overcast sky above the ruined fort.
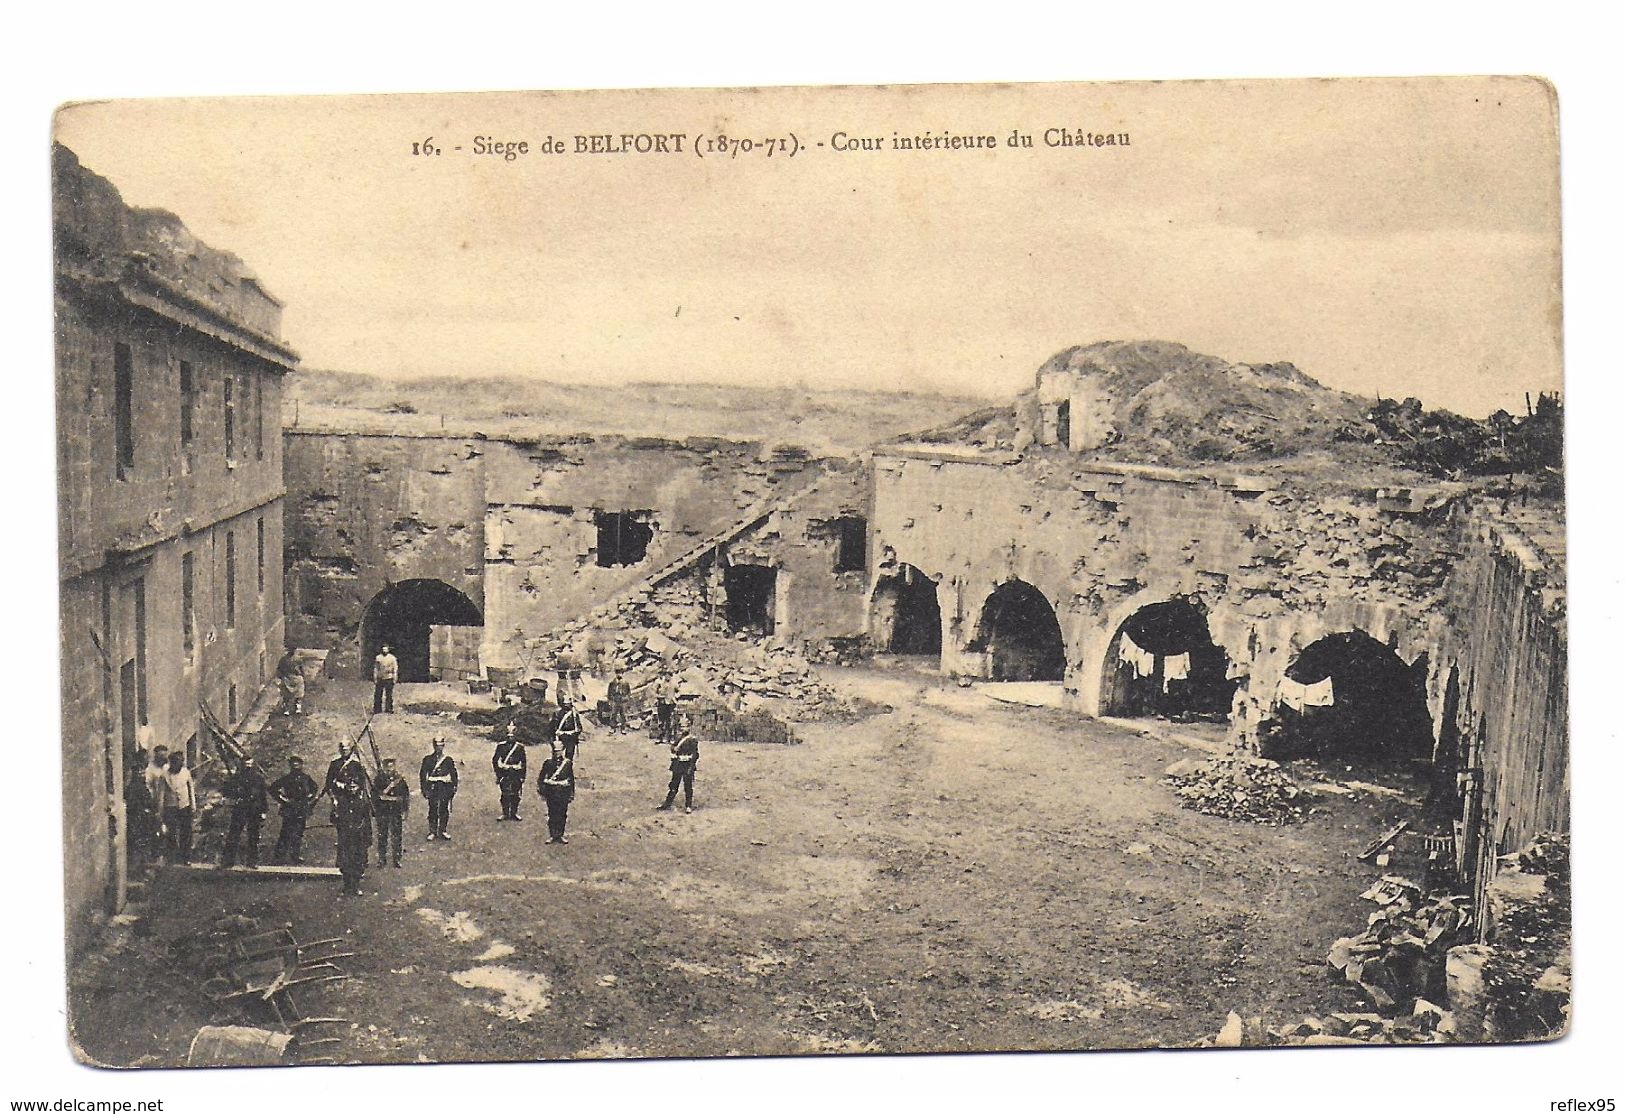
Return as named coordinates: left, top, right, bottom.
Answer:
left=59, top=80, right=1562, bottom=416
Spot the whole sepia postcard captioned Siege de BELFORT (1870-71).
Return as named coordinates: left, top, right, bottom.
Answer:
left=50, top=78, right=1570, bottom=1067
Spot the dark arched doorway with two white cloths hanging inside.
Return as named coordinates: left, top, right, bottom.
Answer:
left=1100, top=596, right=1237, bottom=719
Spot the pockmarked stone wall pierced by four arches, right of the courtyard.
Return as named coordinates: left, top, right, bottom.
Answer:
left=874, top=451, right=1450, bottom=715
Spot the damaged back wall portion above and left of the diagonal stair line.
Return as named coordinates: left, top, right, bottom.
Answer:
left=286, top=430, right=861, bottom=671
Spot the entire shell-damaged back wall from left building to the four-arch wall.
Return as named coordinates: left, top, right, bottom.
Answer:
left=286, top=427, right=868, bottom=680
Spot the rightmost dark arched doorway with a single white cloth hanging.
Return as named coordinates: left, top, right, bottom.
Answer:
left=1259, top=630, right=1433, bottom=760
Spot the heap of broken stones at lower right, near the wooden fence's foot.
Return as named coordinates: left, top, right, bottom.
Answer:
left=1326, top=874, right=1472, bottom=1013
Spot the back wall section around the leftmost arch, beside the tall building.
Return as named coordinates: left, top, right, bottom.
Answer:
left=284, top=430, right=491, bottom=672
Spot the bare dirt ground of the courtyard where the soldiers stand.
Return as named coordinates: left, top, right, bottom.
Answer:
left=73, top=667, right=1415, bottom=1064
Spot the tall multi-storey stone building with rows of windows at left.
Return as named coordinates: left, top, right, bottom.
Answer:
left=52, top=146, right=297, bottom=947
